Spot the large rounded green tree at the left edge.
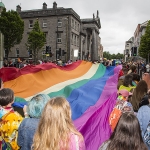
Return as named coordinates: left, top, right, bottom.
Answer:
left=0, top=8, right=24, bottom=58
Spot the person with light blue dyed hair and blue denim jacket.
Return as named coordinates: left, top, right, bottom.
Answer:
left=17, top=94, right=50, bottom=150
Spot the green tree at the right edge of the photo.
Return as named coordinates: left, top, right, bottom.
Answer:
left=139, top=21, right=150, bottom=59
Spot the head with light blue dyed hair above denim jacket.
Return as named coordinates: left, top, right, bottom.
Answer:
left=27, top=94, right=50, bottom=118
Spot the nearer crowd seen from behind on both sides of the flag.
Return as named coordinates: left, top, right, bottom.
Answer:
left=0, top=60, right=150, bottom=150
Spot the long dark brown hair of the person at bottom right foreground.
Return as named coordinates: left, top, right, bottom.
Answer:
left=108, top=112, right=146, bottom=150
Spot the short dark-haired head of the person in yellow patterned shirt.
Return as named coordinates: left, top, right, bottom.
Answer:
left=0, top=88, right=14, bottom=106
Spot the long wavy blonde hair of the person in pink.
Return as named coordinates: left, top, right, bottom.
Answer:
left=32, top=97, right=83, bottom=150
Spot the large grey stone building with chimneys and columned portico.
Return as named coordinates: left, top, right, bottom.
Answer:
left=9, top=2, right=101, bottom=61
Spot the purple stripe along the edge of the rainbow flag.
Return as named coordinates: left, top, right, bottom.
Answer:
left=74, top=66, right=121, bottom=150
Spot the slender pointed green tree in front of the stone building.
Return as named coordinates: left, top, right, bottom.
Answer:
left=26, top=21, right=46, bottom=63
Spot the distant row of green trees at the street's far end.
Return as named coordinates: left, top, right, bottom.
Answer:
left=103, top=52, right=124, bottom=59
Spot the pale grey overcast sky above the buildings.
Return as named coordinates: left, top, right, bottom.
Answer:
left=2, top=0, right=150, bottom=54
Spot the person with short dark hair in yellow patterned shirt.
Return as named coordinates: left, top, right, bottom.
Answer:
left=0, top=88, right=23, bottom=150
